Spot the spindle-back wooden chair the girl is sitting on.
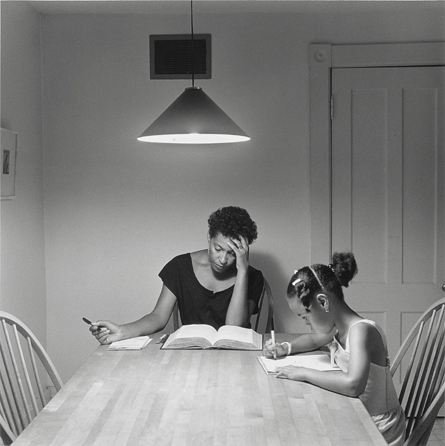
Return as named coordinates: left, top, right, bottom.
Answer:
left=391, top=298, right=445, bottom=446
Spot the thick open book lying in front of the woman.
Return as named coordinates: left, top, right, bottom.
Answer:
left=162, top=324, right=263, bottom=350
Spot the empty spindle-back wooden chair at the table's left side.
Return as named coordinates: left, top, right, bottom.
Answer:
left=0, top=311, right=62, bottom=441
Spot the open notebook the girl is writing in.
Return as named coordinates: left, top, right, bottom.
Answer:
left=258, top=351, right=340, bottom=374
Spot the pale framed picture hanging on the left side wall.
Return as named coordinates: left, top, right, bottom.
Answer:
left=0, top=128, right=17, bottom=200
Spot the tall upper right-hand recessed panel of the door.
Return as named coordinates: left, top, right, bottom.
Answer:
left=403, top=87, right=444, bottom=283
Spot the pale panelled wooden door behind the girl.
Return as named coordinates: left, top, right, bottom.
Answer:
left=331, top=67, right=445, bottom=368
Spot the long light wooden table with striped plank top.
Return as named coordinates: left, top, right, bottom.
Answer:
left=14, top=335, right=386, bottom=446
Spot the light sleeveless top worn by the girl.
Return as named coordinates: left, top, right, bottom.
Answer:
left=328, top=319, right=405, bottom=446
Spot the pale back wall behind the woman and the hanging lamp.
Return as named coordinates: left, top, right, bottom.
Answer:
left=2, top=2, right=445, bottom=380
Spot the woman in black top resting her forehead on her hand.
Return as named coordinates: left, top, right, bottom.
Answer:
left=90, top=206, right=264, bottom=344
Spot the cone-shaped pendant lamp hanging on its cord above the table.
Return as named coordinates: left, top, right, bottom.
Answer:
left=138, top=2, right=250, bottom=144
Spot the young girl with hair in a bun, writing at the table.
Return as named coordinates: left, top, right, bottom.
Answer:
left=264, top=253, right=405, bottom=446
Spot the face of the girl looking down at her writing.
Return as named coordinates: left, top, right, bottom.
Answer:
left=287, top=293, right=334, bottom=334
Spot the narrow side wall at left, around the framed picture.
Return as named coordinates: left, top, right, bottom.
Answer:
left=0, top=1, right=46, bottom=344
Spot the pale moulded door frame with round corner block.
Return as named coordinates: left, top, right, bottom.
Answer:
left=309, top=42, right=445, bottom=263
